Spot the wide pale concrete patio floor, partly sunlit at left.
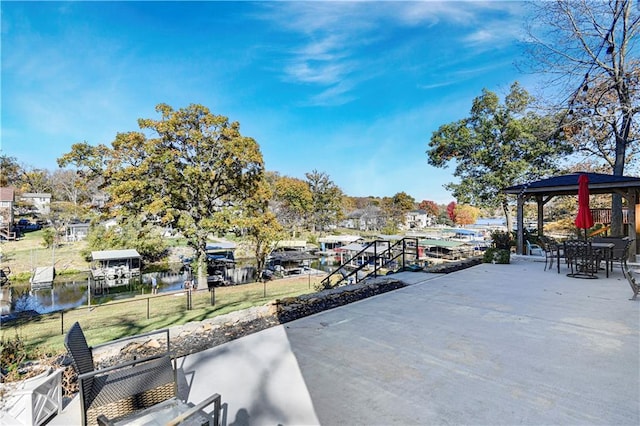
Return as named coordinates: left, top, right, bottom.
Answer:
left=49, top=257, right=640, bottom=426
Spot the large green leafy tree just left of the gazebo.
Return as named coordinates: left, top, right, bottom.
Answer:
left=427, top=82, right=572, bottom=230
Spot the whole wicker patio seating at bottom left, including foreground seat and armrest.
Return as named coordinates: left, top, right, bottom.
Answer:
left=65, top=322, right=221, bottom=426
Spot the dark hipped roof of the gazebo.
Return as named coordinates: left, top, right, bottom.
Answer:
left=504, top=173, right=640, bottom=195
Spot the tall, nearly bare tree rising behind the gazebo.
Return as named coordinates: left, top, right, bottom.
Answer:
left=528, top=0, right=640, bottom=235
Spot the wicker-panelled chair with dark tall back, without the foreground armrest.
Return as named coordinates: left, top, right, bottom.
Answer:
left=64, top=322, right=177, bottom=425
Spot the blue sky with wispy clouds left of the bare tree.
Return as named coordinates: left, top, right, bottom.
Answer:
left=0, top=1, right=534, bottom=203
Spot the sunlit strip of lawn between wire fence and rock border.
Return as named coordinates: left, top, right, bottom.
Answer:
left=0, top=276, right=322, bottom=353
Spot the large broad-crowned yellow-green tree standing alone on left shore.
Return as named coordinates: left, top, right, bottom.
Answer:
left=58, top=104, right=264, bottom=286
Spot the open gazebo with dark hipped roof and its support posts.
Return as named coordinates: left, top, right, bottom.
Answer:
left=503, top=173, right=640, bottom=261
